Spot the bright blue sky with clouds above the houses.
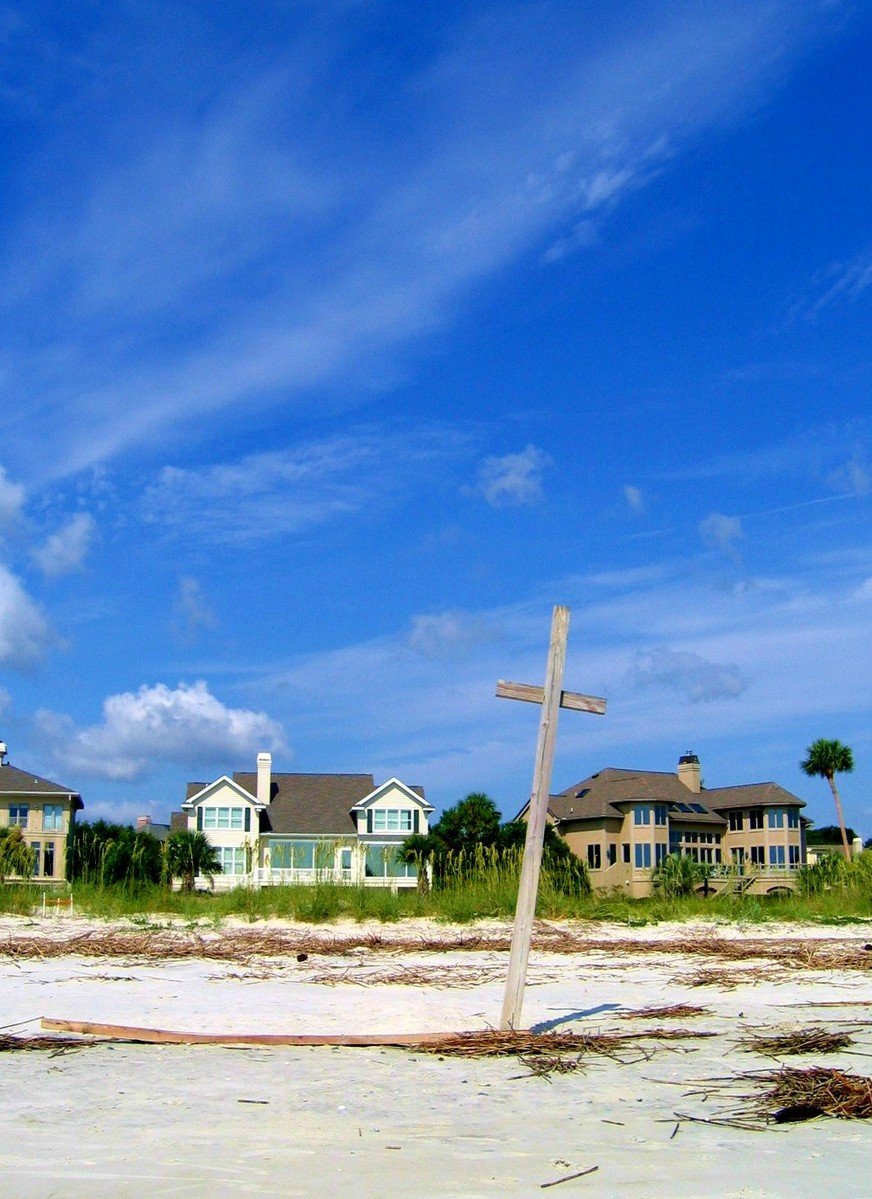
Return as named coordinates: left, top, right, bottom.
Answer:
left=0, top=0, right=872, bottom=836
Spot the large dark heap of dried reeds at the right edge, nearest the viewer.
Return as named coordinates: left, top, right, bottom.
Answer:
left=675, top=1066, right=872, bottom=1128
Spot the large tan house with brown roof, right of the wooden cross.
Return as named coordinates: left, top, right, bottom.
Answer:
left=521, top=752, right=806, bottom=898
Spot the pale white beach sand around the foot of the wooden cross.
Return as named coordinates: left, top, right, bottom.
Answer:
left=0, top=917, right=872, bottom=1199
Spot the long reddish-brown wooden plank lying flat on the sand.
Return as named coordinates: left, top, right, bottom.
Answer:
left=42, top=1017, right=457, bottom=1046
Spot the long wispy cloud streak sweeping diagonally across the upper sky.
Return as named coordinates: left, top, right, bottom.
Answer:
left=0, top=4, right=844, bottom=475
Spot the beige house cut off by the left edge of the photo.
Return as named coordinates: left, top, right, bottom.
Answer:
left=0, top=745, right=84, bottom=882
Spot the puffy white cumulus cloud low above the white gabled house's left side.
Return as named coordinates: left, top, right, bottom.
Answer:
left=35, top=681, right=285, bottom=782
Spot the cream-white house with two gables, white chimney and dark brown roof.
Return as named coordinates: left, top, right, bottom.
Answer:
left=174, top=753, right=433, bottom=888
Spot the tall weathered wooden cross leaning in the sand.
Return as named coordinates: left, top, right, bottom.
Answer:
left=497, top=604, right=606, bottom=1029
